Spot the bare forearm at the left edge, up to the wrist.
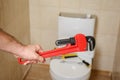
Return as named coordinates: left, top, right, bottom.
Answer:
left=0, top=29, right=24, bottom=55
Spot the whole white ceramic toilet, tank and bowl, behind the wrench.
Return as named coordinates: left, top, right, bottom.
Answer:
left=50, top=13, right=95, bottom=80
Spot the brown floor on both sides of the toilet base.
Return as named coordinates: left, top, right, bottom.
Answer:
left=25, top=65, right=111, bottom=80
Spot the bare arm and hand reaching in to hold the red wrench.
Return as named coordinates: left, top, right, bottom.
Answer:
left=0, top=29, right=43, bottom=61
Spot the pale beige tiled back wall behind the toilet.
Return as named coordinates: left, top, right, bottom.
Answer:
left=29, top=0, right=120, bottom=71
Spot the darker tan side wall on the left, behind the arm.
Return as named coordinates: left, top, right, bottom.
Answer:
left=0, top=0, right=30, bottom=80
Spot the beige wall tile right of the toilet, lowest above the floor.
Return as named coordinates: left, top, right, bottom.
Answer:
left=93, top=35, right=117, bottom=71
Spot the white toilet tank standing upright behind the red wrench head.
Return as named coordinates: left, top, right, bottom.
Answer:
left=58, top=13, right=96, bottom=63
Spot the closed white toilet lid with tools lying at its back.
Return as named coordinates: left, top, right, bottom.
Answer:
left=50, top=59, right=91, bottom=78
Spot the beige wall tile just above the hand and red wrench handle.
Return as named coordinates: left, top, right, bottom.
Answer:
left=31, top=29, right=58, bottom=50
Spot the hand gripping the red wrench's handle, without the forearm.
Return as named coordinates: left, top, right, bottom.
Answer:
left=15, top=45, right=44, bottom=65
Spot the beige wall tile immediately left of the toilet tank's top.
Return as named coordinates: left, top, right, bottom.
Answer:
left=30, top=7, right=59, bottom=29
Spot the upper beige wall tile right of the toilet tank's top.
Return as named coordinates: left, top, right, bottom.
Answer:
left=97, top=11, right=119, bottom=36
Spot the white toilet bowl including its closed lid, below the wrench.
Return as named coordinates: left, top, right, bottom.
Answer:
left=50, top=57, right=91, bottom=80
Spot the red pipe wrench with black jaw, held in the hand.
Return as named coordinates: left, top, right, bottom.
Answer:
left=18, top=34, right=95, bottom=64
